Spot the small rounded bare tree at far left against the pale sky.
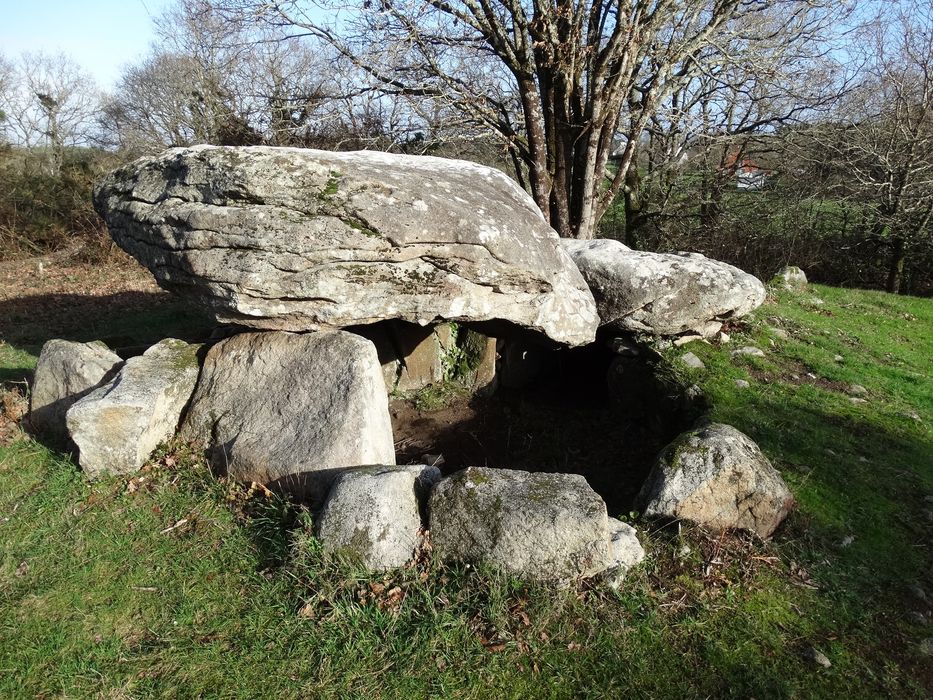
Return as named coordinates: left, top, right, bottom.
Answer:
left=0, top=53, right=100, bottom=174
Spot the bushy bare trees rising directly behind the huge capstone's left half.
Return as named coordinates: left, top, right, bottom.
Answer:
left=104, top=0, right=360, bottom=152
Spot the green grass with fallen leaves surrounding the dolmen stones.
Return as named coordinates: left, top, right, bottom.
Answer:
left=0, top=286, right=933, bottom=700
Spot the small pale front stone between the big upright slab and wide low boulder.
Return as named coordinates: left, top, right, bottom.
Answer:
left=317, top=465, right=441, bottom=571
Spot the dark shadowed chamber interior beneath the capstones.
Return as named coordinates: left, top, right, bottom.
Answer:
left=390, top=343, right=702, bottom=515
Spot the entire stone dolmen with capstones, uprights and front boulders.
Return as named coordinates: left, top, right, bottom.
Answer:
left=31, top=146, right=790, bottom=586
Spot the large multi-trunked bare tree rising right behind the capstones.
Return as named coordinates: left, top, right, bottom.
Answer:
left=217, top=0, right=836, bottom=238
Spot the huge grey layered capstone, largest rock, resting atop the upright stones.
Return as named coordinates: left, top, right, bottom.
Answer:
left=95, top=146, right=598, bottom=345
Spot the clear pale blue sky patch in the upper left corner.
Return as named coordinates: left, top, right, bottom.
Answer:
left=0, top=0, right=170, bottom=89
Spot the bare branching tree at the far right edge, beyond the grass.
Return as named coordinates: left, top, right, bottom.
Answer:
left=800, top=0, right=933, bottom=293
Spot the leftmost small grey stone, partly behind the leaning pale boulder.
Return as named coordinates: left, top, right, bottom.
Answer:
left=29, top=339, right=123, bottom=445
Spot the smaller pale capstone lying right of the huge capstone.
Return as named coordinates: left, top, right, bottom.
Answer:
left=561, top=239, right=765, bottom=338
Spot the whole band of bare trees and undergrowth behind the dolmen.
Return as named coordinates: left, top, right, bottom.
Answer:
left=0, top=0, right=933, bottom=294
